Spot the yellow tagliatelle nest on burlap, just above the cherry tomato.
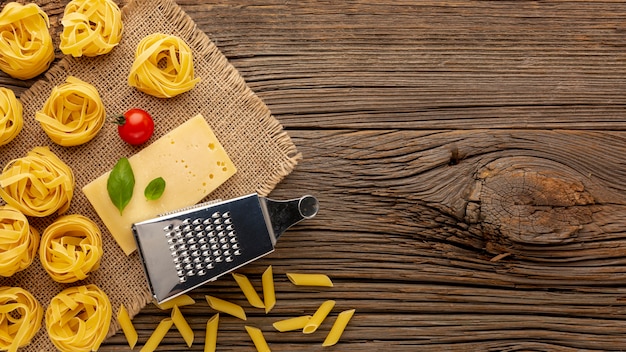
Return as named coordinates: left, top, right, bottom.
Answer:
left=128, top=33, right=200, bottom=98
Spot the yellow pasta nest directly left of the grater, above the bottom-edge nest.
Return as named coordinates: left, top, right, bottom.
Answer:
left=39, top=214, right=103, bottom=283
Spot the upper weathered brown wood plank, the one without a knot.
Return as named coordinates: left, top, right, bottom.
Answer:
left=0, top=0, right=626, bottom=130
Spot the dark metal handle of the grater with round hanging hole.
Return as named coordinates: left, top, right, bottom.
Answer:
left=261, top=195, right=319, bottom=239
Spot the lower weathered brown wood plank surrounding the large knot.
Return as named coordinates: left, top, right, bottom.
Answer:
left=102, top=130, right=626, bottom=351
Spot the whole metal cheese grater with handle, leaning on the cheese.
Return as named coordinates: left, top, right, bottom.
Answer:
left=132, top=194, right=319, bottom=303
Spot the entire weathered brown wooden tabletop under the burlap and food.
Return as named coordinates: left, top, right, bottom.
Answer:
left=0, top=0, right=626, bottom=351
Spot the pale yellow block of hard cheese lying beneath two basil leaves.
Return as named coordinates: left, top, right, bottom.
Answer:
left=83, top=115, right=237, bottom=255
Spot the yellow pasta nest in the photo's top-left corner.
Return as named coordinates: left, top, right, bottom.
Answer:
left=0, top=2, right=54, bottom=79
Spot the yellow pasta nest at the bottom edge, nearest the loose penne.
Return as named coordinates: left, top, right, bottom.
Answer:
left=46, top=284, right=112, bottom=352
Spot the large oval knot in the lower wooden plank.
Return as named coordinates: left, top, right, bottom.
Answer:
left=466, top=158, right=594, bottom=246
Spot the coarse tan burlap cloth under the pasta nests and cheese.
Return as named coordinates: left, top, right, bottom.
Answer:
left=0, top=0, right=301, bottom=351
